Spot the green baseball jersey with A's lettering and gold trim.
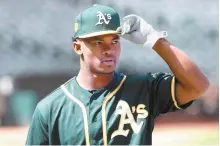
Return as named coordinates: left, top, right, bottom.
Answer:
left=26, top=72, right=192, bottom=145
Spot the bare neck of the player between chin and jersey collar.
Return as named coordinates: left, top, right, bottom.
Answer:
left=76, top=69, right=114, bottom=90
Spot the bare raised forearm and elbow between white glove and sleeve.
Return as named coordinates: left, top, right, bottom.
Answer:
left=153, top=38, right=209, bottom=104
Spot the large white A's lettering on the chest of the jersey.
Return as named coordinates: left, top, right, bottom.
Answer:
left=111, top=100, right=148, bottom=139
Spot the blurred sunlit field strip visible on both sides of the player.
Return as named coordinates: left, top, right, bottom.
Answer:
left=0, top=123, right=219, bottom=146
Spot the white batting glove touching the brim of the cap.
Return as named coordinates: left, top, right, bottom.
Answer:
left=118, top=14, right=168, bottom=48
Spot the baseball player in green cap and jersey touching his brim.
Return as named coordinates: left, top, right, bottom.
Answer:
left=26, top=5, right=209, bottom=145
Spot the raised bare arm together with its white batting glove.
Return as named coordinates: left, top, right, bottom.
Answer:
left=118, top=15, right=209, bottom=105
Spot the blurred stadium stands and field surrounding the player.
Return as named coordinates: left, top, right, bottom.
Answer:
left=0, top=0, right=219, bottom=145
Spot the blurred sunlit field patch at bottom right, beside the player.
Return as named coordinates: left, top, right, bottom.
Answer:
left=153, top=123, right=219, bottom=146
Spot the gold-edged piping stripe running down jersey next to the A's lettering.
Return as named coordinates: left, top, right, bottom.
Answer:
left=102, top=75, right=126, bottom=146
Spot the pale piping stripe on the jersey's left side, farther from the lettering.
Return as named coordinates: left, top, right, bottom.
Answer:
left=61, top=85, right=90, bottom=146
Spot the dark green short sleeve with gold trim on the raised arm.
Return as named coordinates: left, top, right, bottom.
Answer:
left=147, top=72, right=192, bottom=117
